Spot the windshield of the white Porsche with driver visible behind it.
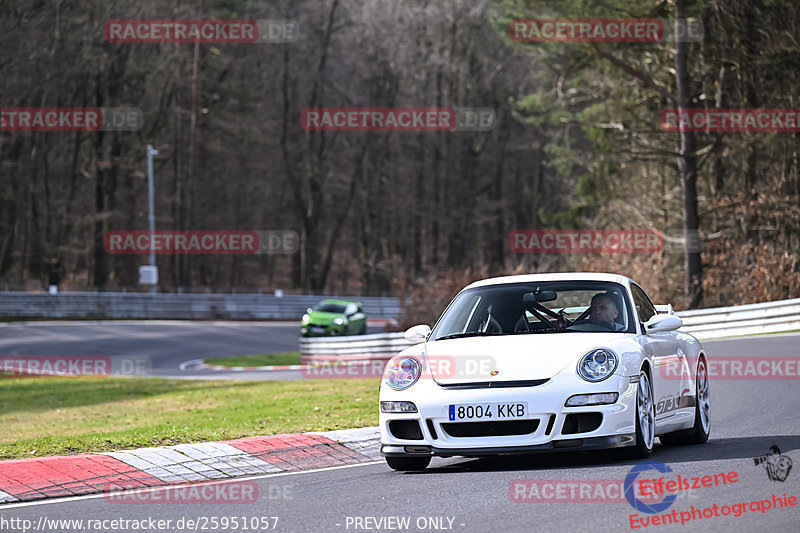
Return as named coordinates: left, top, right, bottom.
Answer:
left=431, top=281, right=636, bottom=340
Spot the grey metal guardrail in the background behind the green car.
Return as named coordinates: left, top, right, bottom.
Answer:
left=0, top=292, right=400, bottom=324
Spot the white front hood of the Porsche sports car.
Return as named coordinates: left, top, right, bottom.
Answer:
left=425, top=332, right=632, bottom=385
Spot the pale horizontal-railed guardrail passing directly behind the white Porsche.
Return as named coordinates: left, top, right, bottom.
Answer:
left=300, top=298, right=800, bottom=360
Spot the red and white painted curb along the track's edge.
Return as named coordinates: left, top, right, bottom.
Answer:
left=0, top=427, right=380, bottom=503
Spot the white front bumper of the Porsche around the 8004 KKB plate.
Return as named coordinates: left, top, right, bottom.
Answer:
left=379, top=374, right=637, bottom=457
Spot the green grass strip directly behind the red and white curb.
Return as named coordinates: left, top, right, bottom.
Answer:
left=0, top=378, right=379, bottom=459
